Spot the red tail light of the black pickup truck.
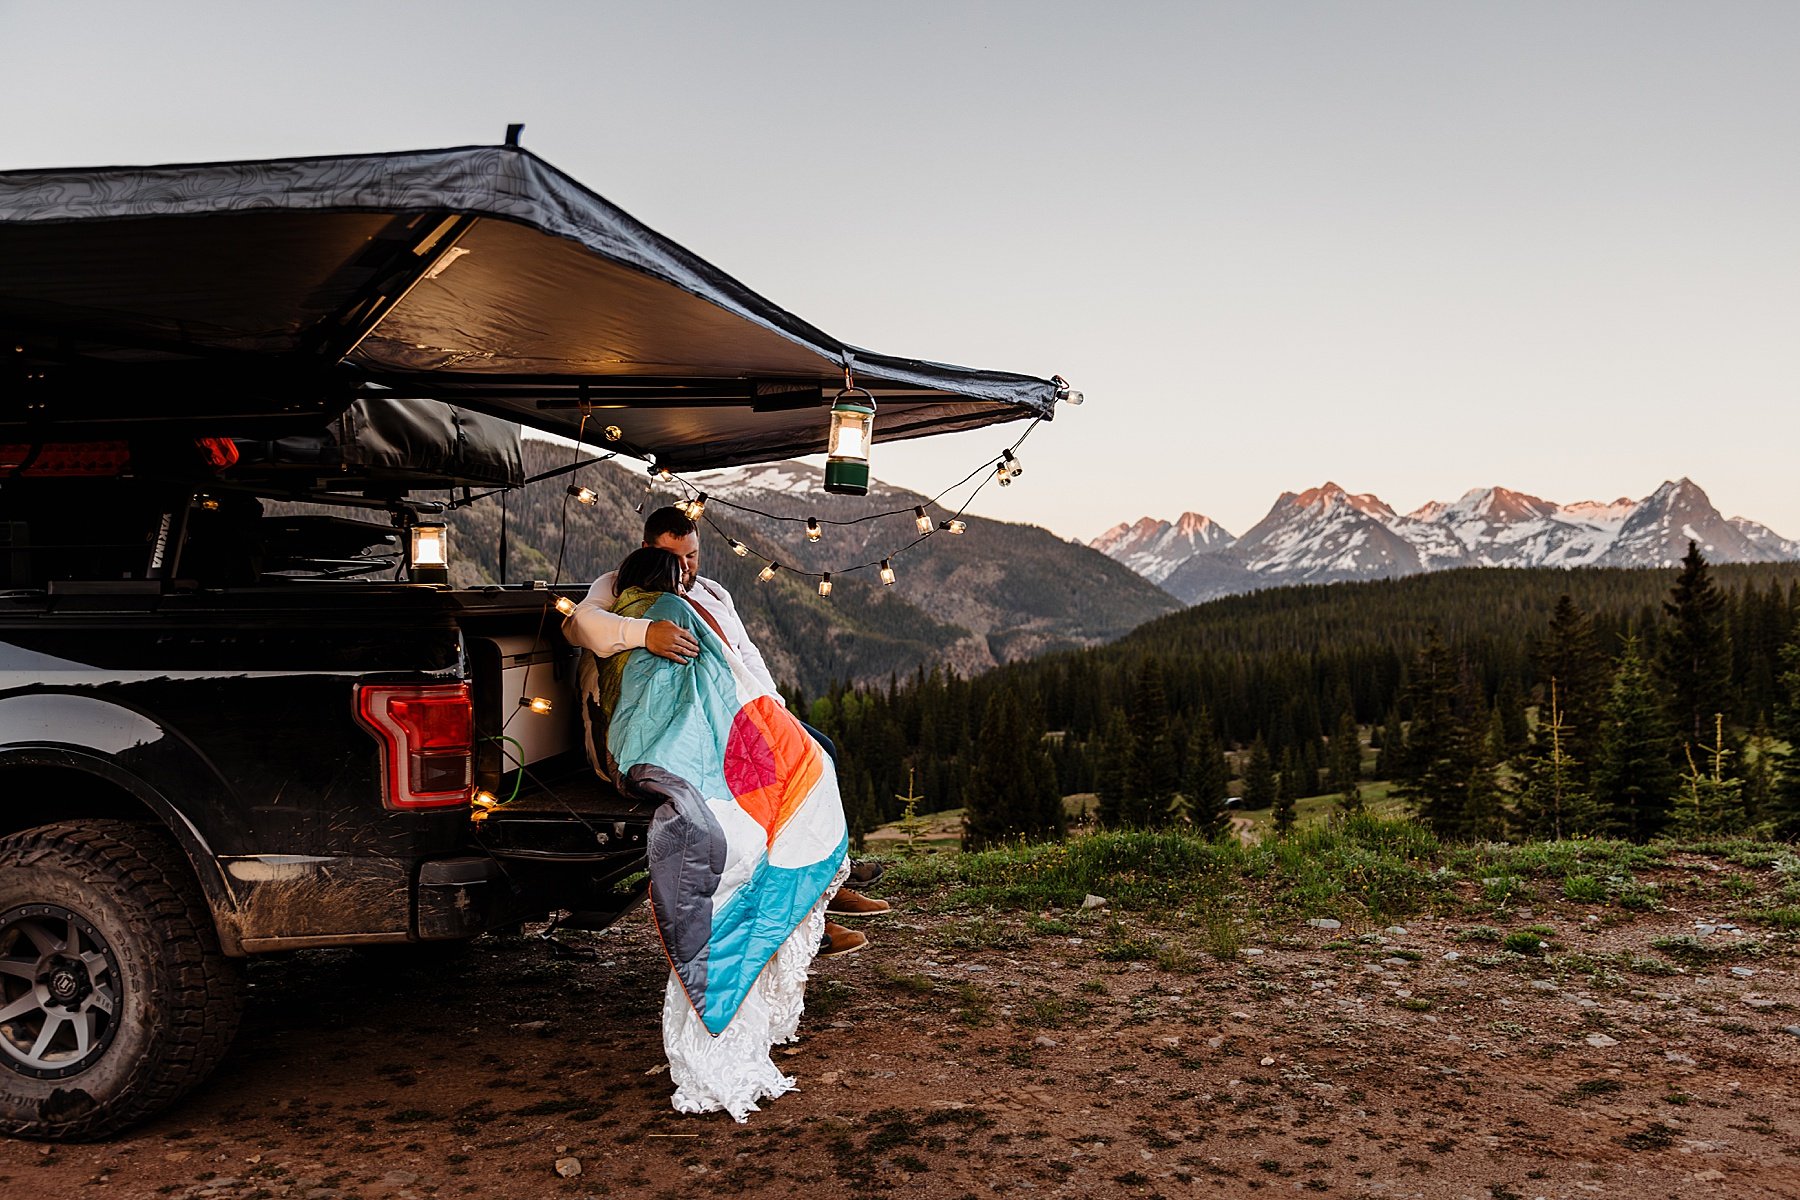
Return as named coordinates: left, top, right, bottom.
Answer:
left=356, top=684, right=475, bottom=810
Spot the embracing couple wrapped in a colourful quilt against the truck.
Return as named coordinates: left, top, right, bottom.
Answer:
left=563, top=507, right=886, bottom=1121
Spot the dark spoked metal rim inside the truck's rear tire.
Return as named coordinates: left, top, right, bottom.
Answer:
left=0, top=905, right=122, bottom=1079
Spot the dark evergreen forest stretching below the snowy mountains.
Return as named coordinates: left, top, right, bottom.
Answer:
left=806, top=549, right=1800, bottom=847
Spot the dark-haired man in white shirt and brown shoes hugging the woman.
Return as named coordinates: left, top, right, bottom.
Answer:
left=563, top=506, right=887, bottom=954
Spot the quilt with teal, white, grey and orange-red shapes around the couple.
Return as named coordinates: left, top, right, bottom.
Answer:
left=599, top=588, right=850, bottom=1036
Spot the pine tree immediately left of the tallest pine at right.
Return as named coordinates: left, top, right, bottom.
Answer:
left=1593, top=639, right=1676, bottom=842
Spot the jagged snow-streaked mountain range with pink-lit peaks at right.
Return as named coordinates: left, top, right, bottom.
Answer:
left=1091, top=479, right=1800, bottom=604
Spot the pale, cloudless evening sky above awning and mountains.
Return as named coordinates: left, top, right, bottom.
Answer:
left=0, top=0, right=1800, bottom=540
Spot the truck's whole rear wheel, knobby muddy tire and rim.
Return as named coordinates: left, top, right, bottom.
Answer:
left=0, top=820, right=243, bottom=1141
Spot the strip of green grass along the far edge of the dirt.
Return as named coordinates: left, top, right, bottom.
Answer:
left=886, top=815, right=1800, bottom=935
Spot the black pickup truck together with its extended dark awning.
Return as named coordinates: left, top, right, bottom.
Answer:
left=0, top=140, right=1075, bottom=1139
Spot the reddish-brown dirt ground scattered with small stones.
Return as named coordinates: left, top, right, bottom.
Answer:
left=0, top=864, right=1800, bottom=1200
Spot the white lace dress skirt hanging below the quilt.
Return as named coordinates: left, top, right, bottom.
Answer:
left=662, top=858, right=850, bottom=1121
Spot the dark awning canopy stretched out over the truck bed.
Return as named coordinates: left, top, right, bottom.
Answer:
left=0, top=146, right=1058, bottom=470
